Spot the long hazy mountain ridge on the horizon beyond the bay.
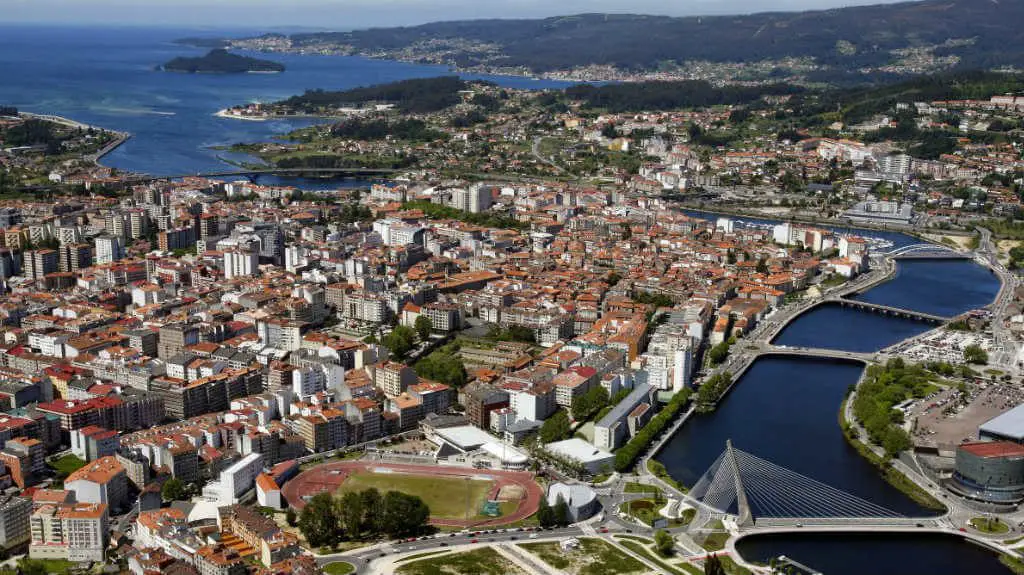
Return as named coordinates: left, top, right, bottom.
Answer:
left=214, top=0, right=1024, bottom=79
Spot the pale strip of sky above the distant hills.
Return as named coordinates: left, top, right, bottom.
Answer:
left=0, top=0, right=909, bottom=30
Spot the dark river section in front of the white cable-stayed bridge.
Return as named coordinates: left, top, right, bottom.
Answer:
left=736, top=532, right=1010, bottom=575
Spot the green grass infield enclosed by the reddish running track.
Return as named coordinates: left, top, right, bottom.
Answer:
left=338, top=473, right=493, bottom=519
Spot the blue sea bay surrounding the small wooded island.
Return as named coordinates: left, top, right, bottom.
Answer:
left=0, top=24, right=569, bottom=175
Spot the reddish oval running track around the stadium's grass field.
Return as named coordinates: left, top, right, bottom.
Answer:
left=281, top=461, right=544, bottom=527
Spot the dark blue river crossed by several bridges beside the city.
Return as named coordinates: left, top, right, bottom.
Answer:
left=658, top=213, right=1008, bottom=575
